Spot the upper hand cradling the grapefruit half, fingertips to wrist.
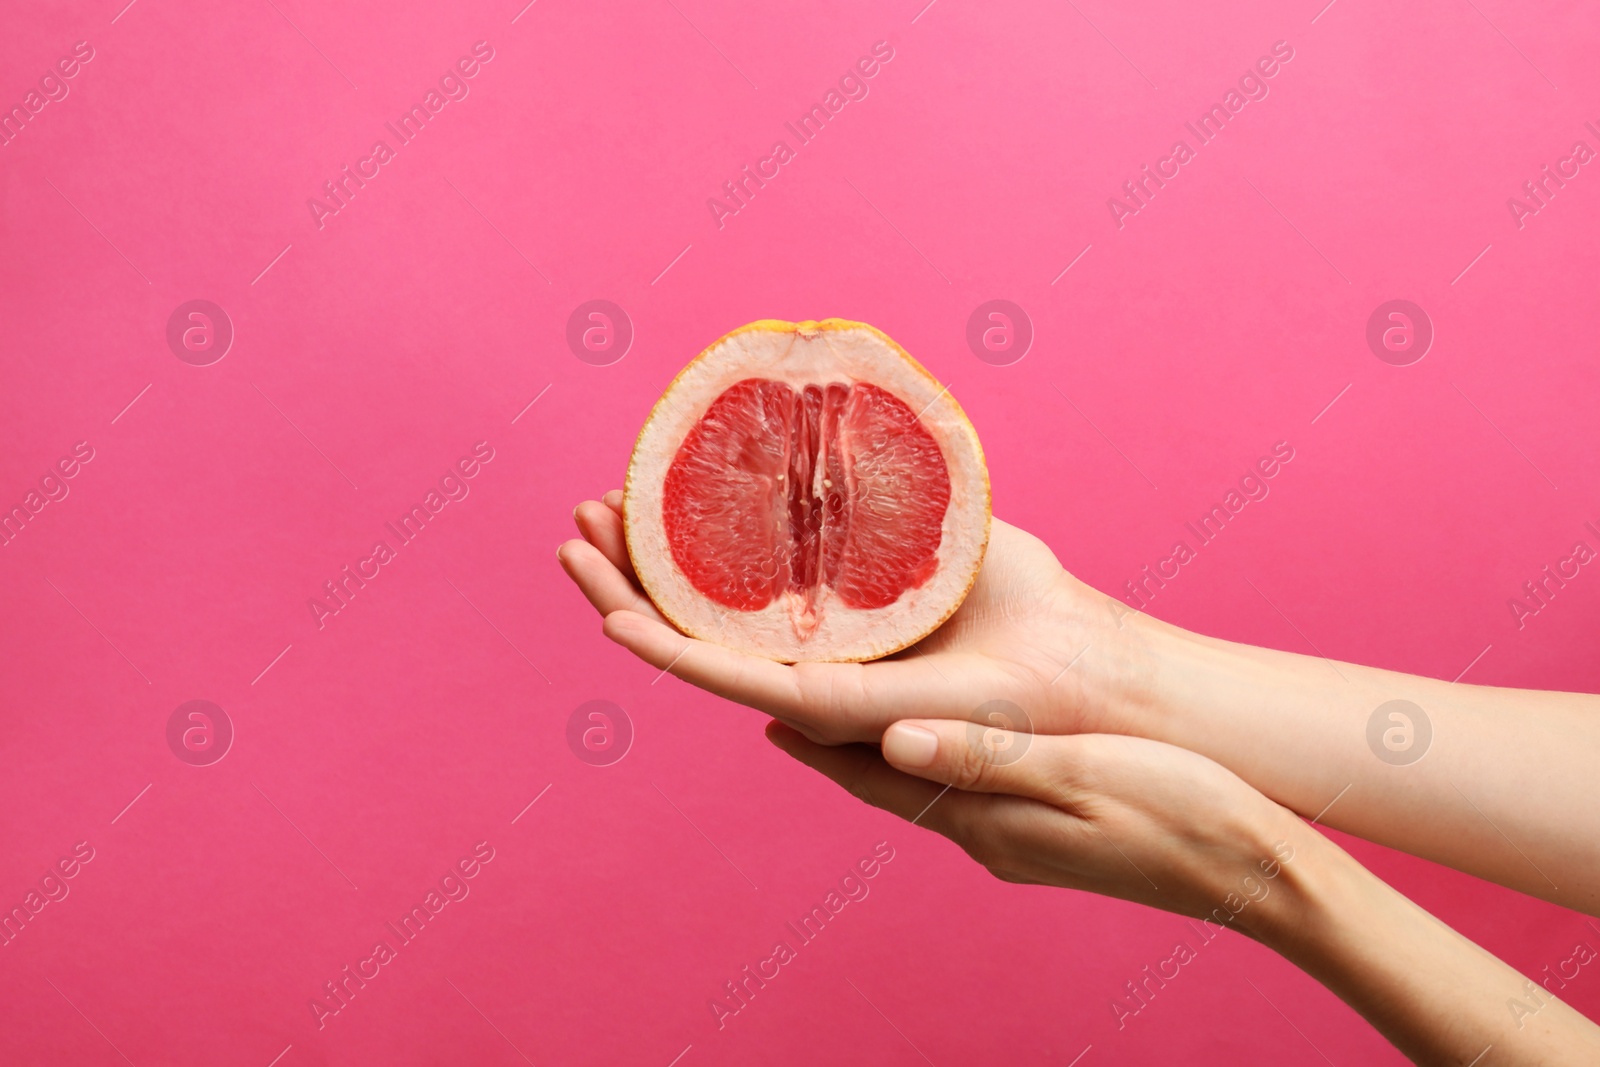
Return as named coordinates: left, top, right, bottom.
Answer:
left=557, top=491, right=1147, bottom=744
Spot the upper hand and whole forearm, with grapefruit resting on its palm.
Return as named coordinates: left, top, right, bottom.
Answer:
left=558, top=493, right=1600, bottom=915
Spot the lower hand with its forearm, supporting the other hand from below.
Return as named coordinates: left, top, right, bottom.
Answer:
left=766, top=720, right=1600, bottom=1067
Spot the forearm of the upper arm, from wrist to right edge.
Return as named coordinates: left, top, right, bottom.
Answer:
left=1130, top=604, right=1600, bottom=913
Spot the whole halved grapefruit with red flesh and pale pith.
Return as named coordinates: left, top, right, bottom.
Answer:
left=622, top=318, right=989, bottom=662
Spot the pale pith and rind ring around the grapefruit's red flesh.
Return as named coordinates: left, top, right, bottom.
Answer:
left=622, top=318, right=990, bottom=662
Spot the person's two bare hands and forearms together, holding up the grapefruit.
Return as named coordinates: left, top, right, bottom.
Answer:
left=557, top=493, right=1600, bottom=1067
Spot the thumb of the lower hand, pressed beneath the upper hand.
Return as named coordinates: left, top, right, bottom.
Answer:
left=882, top=718, right=1077, bottom=805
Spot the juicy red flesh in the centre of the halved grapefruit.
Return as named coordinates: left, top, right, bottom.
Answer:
left=664, top=378, right=950, bottom=616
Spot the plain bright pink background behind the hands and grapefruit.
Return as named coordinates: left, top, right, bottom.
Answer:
left=0, top=0, right=1600, bottom=1067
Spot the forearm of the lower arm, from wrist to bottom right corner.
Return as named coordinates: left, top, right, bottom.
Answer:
left=1248, top=825, right=1600, bottom=1067
